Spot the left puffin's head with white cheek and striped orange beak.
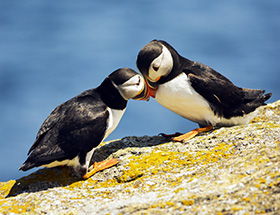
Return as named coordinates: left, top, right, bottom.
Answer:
left=108, top=68, right=150, bottom=101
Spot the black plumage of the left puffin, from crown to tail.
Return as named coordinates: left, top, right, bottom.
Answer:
left=20, top=68, right=142, bottom=175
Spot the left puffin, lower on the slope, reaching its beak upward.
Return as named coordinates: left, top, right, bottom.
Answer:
left=19, top=68, right=149, bottom=179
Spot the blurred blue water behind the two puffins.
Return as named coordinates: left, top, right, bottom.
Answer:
left=0, top=0, right=280, bottom=181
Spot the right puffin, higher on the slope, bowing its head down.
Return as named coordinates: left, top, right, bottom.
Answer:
left=136, top=40, right=272, bottom=142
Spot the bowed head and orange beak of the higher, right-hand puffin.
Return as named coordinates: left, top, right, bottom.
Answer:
left=136, top=40, right=173, bottom=97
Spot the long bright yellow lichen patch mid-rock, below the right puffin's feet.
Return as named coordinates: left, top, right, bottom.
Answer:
left=118, top=143, right=234, bottom=184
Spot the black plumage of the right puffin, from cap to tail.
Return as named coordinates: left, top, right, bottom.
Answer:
left=137, top=40, right=272, bottom=126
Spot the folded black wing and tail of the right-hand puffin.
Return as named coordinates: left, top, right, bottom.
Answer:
left=183, top=62, right=271, bottom=118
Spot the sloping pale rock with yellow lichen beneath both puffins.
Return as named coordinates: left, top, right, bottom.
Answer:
left=0, top=101, right=280, bottom=214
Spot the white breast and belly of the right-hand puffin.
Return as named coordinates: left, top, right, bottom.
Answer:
left=155, top=73, right=218, bottom=125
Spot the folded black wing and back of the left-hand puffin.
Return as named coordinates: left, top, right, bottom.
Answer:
left=20, top=89, right=109, bottom=170
